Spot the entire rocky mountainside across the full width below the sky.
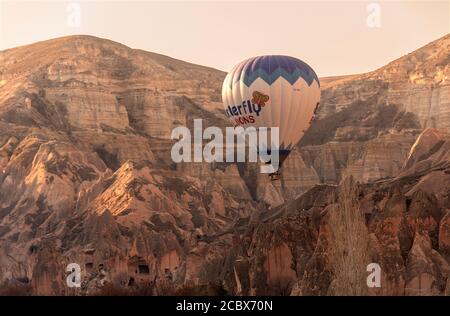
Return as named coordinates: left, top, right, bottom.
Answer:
left=0, top=36, right=450, bottom=294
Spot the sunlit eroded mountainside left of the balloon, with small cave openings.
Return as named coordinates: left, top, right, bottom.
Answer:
left=0, top=36, right=239, bottom=294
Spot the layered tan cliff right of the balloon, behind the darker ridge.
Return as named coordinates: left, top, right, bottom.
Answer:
left=292, top=35, right=450, bottom=195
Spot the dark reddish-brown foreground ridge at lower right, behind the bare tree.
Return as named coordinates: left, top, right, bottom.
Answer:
left=230, top=129, right=450, bottom=295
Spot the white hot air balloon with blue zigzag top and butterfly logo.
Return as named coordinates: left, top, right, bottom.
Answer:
left=222, top=55, right=320, bottom=179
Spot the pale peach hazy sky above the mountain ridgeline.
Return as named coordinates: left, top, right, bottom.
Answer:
left=0, top=0, right=450, bottom=76
